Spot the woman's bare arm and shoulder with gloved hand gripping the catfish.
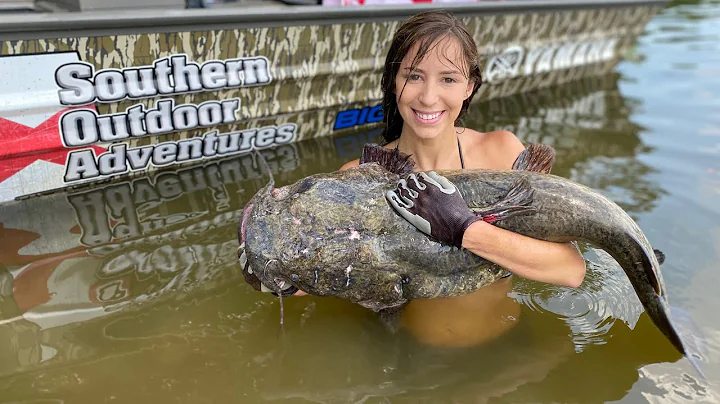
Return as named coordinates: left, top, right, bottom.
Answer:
left=387, top=131, right=586, bottom=287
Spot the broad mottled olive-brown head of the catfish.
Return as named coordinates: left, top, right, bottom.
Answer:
left=238, top=165, right=407, bottom=310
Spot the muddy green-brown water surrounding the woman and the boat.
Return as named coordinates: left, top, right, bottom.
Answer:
left=0, top=2, right=720, bottom=404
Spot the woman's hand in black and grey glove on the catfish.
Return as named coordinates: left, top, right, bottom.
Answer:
left=385, top=171, right=482, bottom=248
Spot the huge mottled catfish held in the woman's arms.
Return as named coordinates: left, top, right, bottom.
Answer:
left=238, top=145, right=700, bottom=376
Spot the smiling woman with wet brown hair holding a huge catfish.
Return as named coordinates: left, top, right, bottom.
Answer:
left=299, top=11, right=585, bottom=346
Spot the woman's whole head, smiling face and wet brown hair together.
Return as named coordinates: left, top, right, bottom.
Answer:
left=382, top=12, right=482, bottom=155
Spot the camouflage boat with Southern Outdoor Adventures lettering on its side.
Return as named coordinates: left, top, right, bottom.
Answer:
left=0, top=0, right=666, bottom=204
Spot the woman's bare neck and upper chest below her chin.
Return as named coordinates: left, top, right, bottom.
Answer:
left=397, top=128, right=461, bottom=171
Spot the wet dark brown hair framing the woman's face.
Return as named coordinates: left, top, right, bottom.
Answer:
left=380, top=10, right=482, bottom=144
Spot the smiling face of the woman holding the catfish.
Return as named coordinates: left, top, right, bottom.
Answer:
left=395, top=38, right=473, bottom=139
